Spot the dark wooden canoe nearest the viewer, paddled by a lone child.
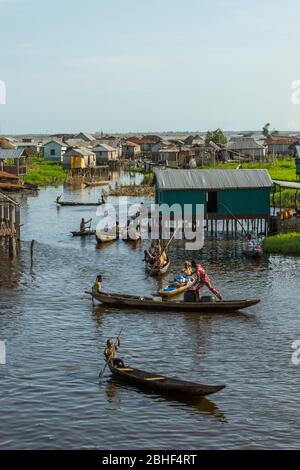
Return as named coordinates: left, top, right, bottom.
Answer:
left=108, top=361, right=225, bottom=396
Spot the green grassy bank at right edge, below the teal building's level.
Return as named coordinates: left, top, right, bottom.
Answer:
left=263, top=232, right=300, bottom=255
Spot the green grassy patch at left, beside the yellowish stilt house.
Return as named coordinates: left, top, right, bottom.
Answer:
left=24, top=157, right=67, bottom=186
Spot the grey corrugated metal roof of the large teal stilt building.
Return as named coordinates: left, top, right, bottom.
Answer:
left=154, top=168, right=273, bottom=190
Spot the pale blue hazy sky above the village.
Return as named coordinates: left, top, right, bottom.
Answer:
left=0, top=0, right=300, bottom=134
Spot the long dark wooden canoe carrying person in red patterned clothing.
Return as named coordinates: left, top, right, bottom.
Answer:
left=86, top=292, right=260, bottom=314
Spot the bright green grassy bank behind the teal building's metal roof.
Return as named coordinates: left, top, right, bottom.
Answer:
left=205, top=158, right=297, bottom=181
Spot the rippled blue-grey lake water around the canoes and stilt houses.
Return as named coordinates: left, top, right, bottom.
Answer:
left=0, top=179, right=300, bottom=449
